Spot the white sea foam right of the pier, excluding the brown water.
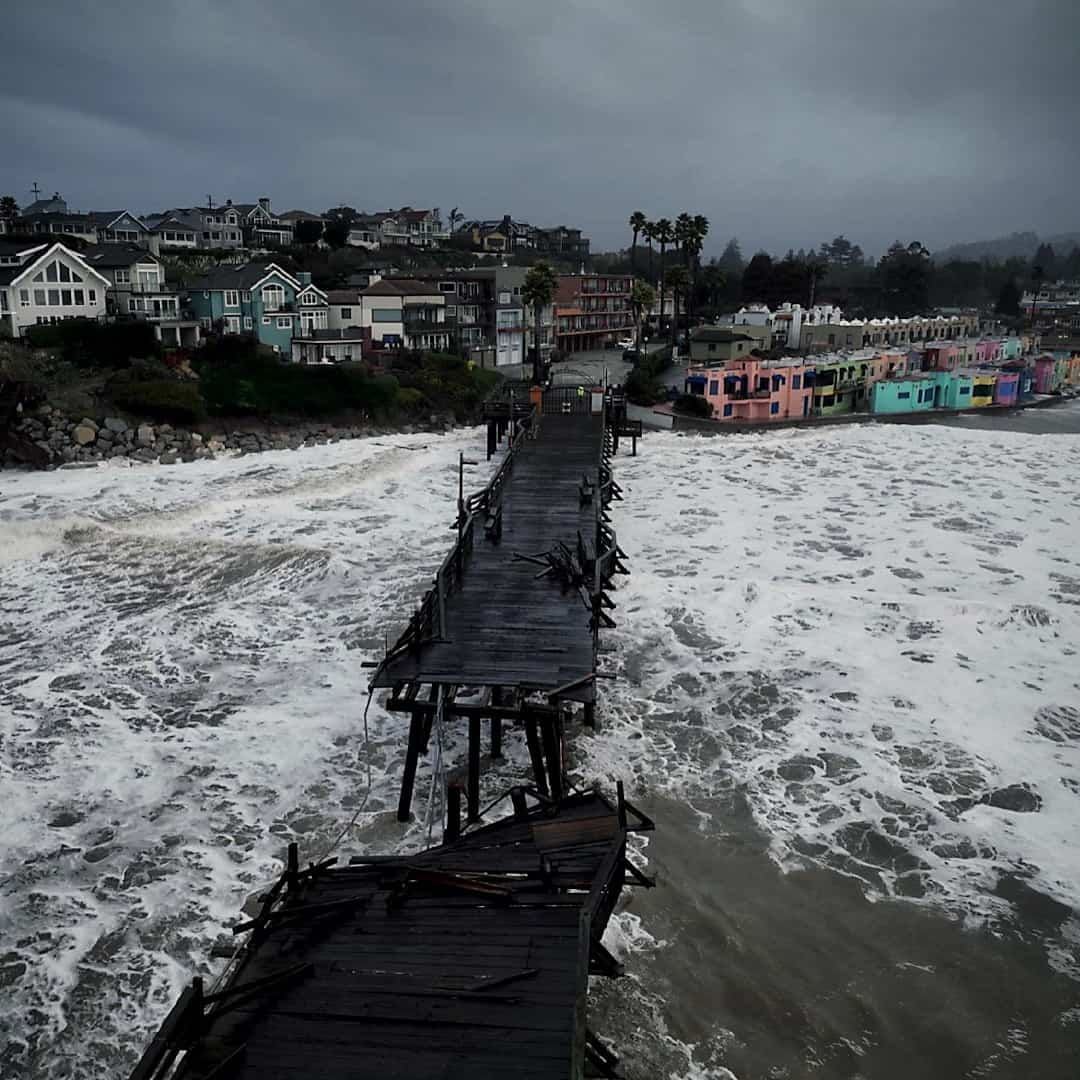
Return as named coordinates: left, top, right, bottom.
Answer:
left=585, top=426, right=1080, bottom=933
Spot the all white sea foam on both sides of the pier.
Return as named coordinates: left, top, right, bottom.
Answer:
left=0, top=416, right=1080, bottom=1077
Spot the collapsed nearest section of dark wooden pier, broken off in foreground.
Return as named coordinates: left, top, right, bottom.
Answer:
left=131, top=788, right=652, bottom=1080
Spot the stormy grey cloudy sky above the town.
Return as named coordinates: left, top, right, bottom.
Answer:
left=0, top=0, right=1080, bottom=254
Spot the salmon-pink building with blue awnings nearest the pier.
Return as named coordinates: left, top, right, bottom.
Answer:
left=686, top=356, right=815, bottom=423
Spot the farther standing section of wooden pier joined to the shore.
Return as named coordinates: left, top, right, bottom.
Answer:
left=372, top=388, right=640, bottom=821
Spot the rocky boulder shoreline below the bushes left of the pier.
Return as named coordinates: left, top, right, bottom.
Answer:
left=0, top=408, right=456, bottom=469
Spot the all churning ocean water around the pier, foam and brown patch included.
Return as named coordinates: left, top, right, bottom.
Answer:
left=0, top=416, right=1080, bottom=1080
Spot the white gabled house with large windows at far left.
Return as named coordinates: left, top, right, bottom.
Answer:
left=0, top=241, right=109, bottom=338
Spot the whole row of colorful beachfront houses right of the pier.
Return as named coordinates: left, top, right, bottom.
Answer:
left=685, top=337, right=1080, bottom=423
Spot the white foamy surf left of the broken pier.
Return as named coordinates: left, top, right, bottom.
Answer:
left=0, top=431, right=505, bottom=1077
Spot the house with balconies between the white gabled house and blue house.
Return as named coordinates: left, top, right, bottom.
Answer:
left=82, top=243, right=202, bottom=349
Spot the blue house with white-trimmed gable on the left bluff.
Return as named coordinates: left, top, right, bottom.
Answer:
left=185, top=262, right=329, bottom=356
